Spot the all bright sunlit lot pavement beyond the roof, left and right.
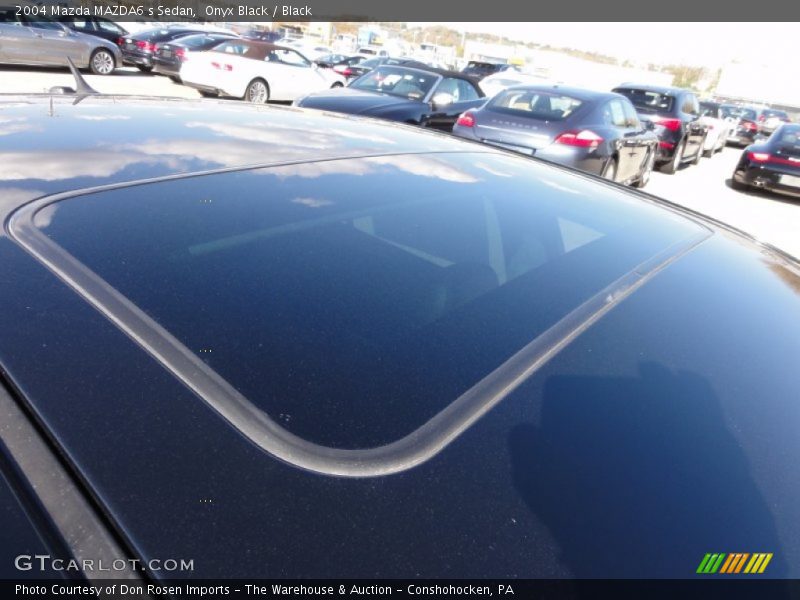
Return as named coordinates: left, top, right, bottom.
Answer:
left=0, top=67, right=800, bottom=258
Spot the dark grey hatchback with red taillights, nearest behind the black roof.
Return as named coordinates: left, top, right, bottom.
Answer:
left=453, top=85, right=658, bottom=187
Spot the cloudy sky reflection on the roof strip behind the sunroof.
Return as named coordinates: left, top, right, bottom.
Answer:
left=0, top=97, right=476, bottom=199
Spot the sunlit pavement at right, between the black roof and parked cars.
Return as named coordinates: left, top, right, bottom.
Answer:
left=646, top=147, right=800, bottom=258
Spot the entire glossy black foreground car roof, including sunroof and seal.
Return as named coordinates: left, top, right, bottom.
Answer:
left=0, top=96, right=800, bottom=579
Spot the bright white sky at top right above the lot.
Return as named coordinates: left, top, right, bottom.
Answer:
left=412, top=23, right=800, bottom=68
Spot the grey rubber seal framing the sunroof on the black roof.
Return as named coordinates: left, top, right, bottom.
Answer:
left=6, top=153, right=712, bottom=477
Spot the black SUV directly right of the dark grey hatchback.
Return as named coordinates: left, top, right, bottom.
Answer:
left=613, top=83, right=706, bottom=174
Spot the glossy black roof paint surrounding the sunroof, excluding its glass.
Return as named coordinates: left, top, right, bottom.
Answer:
left=0, top=97, right=800, bottom=578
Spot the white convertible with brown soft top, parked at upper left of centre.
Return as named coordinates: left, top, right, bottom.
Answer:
left=180, top=40, right=346, bottom=104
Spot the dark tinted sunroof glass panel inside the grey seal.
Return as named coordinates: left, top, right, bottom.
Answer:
left=34, top=152, right=703, bottom=448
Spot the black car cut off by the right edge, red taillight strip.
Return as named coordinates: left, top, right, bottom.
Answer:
left=731, top=124, right=800, bottom=196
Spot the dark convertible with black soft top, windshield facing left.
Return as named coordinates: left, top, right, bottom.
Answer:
left=294, top=63, right=484, bottom=131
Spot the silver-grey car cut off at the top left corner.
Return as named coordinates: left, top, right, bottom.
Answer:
left=0, top=5, right=122, bottom=75
